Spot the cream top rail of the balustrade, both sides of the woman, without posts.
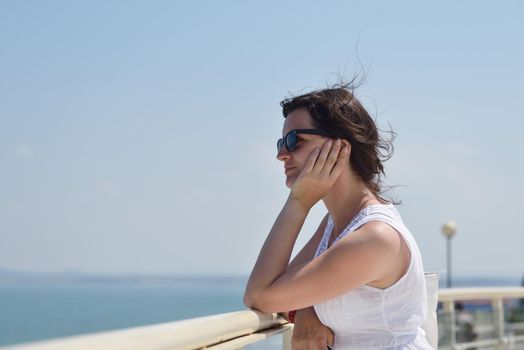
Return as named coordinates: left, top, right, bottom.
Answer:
left=0, top=287, right=524, bottom=350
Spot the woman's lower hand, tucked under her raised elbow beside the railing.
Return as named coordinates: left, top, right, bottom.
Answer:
left=291, top=306, right=335, bottom=350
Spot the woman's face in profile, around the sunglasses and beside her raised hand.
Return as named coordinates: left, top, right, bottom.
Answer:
left=277, top=108, right=328, bottom=188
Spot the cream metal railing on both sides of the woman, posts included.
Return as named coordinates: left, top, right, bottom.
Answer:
left=0, top=288, right=524, bottom=350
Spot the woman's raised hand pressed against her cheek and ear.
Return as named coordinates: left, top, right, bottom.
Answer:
left=290, top=139, right=350, bottom=210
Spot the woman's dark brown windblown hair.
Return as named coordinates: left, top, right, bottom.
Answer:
left=280, top=81, right=396, bottom=202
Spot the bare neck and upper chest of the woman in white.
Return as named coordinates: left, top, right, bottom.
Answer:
left=323, top=172, right=381, bottom=234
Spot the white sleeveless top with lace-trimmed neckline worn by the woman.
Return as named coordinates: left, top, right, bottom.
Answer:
left=314, top=204, right=433, bottom=350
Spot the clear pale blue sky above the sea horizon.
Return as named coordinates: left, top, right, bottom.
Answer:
left=0, top=0, right=524, bottom=278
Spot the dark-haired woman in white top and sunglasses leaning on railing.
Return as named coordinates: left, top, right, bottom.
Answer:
left=244, top=85, right=431, bottom=350
